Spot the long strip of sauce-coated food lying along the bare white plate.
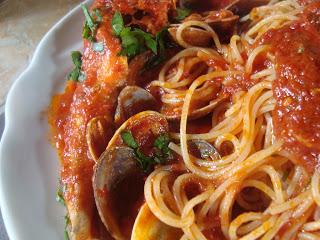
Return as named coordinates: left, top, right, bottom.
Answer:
left=49, top=2, right=128, bottom=236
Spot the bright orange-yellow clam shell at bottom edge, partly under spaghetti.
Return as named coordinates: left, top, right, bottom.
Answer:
left=131, top=203, right=183, bottom=240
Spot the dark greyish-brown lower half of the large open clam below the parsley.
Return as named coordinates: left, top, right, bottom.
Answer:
left=93, top=147, right=144, bottom=239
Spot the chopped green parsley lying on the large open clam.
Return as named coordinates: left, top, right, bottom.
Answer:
left=121, top=131, right=170, bottom=172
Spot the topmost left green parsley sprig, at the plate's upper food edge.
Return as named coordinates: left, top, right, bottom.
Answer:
left=81, top=4, right=102, bottom=42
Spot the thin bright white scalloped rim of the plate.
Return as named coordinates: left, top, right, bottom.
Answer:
left=0, top=0, right=92, bottom=239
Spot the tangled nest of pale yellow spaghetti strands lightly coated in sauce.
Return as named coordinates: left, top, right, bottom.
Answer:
left=145, top=0, right=320, bottom=240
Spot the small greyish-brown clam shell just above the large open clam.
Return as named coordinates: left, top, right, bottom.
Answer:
left=114, top=86, right=157, bottom=125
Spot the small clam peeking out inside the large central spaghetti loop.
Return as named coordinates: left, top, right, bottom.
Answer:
left=188, top=139, right=221, bottom=161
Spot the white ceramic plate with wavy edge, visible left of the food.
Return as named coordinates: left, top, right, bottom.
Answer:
left=0, top=1, right=90, bottom=240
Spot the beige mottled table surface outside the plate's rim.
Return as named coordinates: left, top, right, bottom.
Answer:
left=0, top=0, right=81, bottom=237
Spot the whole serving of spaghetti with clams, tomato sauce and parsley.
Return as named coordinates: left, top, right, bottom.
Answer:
left=49, top=0, right=320, bottom=240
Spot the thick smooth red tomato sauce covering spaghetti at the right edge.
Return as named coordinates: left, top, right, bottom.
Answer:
left=261, top=2, right=320, bottom=172
